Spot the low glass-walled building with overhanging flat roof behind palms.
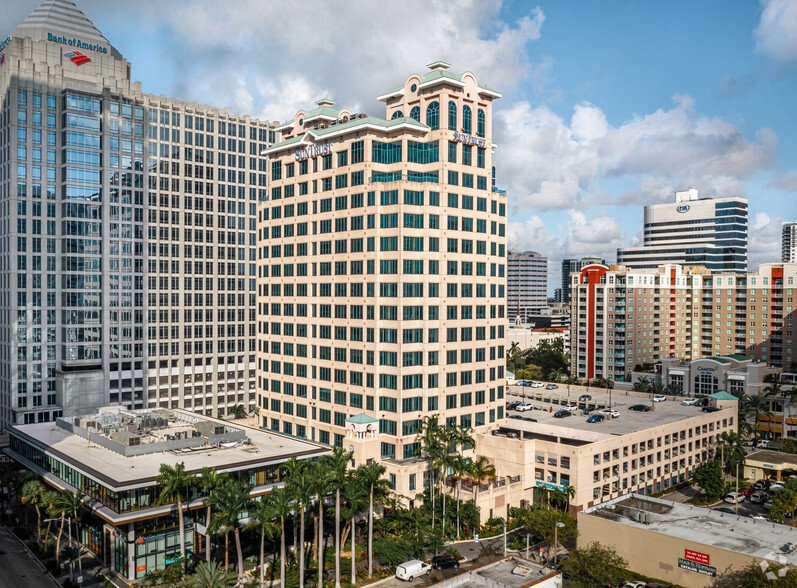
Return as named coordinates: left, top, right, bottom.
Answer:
left=6, top=408, right=329, bottom=580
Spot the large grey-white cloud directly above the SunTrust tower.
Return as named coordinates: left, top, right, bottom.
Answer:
left=110, top=0, right=550, bottom=120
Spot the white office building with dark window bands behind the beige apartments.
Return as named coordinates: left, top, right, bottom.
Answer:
left=617, top=188, right=747, bottom=273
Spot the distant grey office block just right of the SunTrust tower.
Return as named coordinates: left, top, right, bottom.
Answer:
left=506, top=251, right=548, bottom=323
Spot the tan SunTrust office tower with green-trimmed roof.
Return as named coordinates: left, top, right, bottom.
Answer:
left=257, top=62, right=506, bottom=496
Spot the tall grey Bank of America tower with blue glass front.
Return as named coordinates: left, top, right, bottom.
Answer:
left=0, top=0, right=274, bottom=426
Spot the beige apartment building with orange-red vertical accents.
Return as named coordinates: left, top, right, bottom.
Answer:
left=570, top=263, right=797, bottom=380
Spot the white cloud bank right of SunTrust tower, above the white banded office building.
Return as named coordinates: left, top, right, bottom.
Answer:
left=495, top=95, right=777, bottom=214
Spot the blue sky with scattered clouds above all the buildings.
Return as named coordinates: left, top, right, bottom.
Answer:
left=6, top=0, right=797, bottom=291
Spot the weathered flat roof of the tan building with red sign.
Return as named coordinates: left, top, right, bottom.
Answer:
left=578, top=494, right=797, bottom=566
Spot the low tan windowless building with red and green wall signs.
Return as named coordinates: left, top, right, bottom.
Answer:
left=578, top=494, right=797, bottom=588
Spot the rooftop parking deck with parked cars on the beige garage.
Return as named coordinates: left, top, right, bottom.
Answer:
left=501, top=385, right=737, bottom=442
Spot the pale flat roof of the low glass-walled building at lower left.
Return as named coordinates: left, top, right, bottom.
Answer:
left=7, top=410, right=330, bottom=491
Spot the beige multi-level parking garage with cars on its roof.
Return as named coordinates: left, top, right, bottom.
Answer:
left=472, top=387, right=738, bottom=518
